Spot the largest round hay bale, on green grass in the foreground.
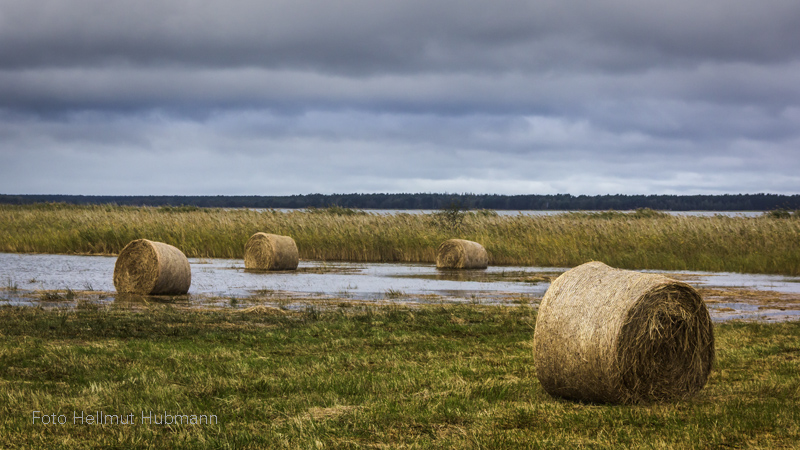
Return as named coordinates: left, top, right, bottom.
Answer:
left=533, top=261, right=714, bottom=403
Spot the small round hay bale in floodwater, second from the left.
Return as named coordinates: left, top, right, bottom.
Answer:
left=244, top=233, right=300, bottom=270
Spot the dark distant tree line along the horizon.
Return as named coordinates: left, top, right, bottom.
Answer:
left=0, top=193, right=800, bottom=211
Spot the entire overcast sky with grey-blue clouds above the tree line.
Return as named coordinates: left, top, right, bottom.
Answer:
left=0, top=0, right=800, bottom=195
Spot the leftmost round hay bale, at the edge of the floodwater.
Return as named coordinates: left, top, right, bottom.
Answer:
left=114, top=239, right=192, bottom=295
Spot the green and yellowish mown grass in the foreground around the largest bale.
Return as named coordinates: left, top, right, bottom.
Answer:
left=0, top=305, right=800, bottom=449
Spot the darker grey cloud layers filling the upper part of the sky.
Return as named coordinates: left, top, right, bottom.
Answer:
left=0, top=0, right=800, bottom=114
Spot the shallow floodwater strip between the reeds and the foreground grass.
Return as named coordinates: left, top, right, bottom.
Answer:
left=0, top=253, right=800, bottom=321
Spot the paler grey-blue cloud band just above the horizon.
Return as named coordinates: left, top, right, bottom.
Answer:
left=0, top=111, right=800, bottom=194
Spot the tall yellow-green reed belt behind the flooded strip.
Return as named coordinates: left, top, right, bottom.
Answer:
left=0, top=204, right=800, bottom=275
